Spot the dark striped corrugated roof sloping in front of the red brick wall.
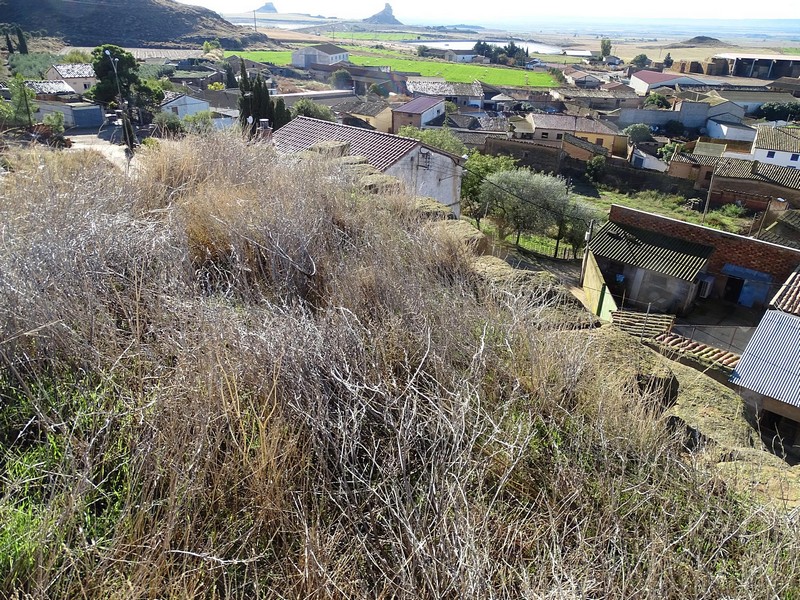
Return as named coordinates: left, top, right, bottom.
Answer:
left=589, top=222, right=714, bottom=281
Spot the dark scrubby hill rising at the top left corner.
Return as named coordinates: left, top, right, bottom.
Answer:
left=0, top=0, right=267, bottom=48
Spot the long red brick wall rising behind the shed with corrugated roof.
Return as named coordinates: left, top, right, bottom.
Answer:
left=609, top=204, right=800, bottom=283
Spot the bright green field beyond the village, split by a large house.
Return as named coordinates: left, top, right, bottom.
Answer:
left=237, top=48, right=555, bottom=87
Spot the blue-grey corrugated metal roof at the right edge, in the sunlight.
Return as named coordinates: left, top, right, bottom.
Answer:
left=730, top=310, right=800, bottom=407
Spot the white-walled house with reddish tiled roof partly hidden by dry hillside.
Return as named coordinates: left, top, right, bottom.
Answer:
left=272, top=117, right=462, bottom=216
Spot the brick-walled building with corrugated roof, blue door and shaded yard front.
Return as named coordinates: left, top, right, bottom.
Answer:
left=589, top=204, right=800, bottom=314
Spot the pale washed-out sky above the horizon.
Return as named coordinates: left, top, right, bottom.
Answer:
left=178, top=0, right=800, bottom=22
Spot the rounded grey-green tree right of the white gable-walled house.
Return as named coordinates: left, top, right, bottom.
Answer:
left=480, top=169, right=569, bottom=244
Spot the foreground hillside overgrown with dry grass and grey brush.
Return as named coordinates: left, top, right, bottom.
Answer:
left=0, top=137, right=800, bottom=599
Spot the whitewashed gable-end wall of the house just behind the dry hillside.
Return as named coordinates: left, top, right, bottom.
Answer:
left=385, top=146, right=462, bottom=217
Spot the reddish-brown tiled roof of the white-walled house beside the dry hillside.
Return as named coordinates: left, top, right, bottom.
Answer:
left=272, top=117, right=420, bottom=171
